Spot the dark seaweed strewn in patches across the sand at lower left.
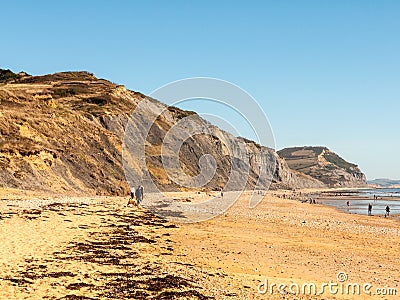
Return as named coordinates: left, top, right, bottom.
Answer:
left=3, top=200, right=211, bottom=300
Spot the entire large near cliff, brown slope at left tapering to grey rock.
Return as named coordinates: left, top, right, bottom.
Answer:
left=0, top=72, right=323, bottom=195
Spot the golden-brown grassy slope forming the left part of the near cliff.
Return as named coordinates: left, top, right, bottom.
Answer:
left=0, top=72, right=140, bottom=195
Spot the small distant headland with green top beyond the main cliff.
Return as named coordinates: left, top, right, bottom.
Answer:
left=278, top=147, right=367, bottom=187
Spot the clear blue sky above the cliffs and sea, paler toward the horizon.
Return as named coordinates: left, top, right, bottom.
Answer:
left=0, top=0, right=400, bottom=179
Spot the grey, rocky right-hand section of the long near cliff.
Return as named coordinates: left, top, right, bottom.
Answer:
left=98, top=94, right=324, bottom=191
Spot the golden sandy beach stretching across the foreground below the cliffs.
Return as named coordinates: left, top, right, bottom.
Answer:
left=0, top=190, right=400, bottom=299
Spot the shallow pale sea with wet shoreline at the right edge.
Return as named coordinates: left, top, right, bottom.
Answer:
left=321, top=188, right=400, bottom=216
